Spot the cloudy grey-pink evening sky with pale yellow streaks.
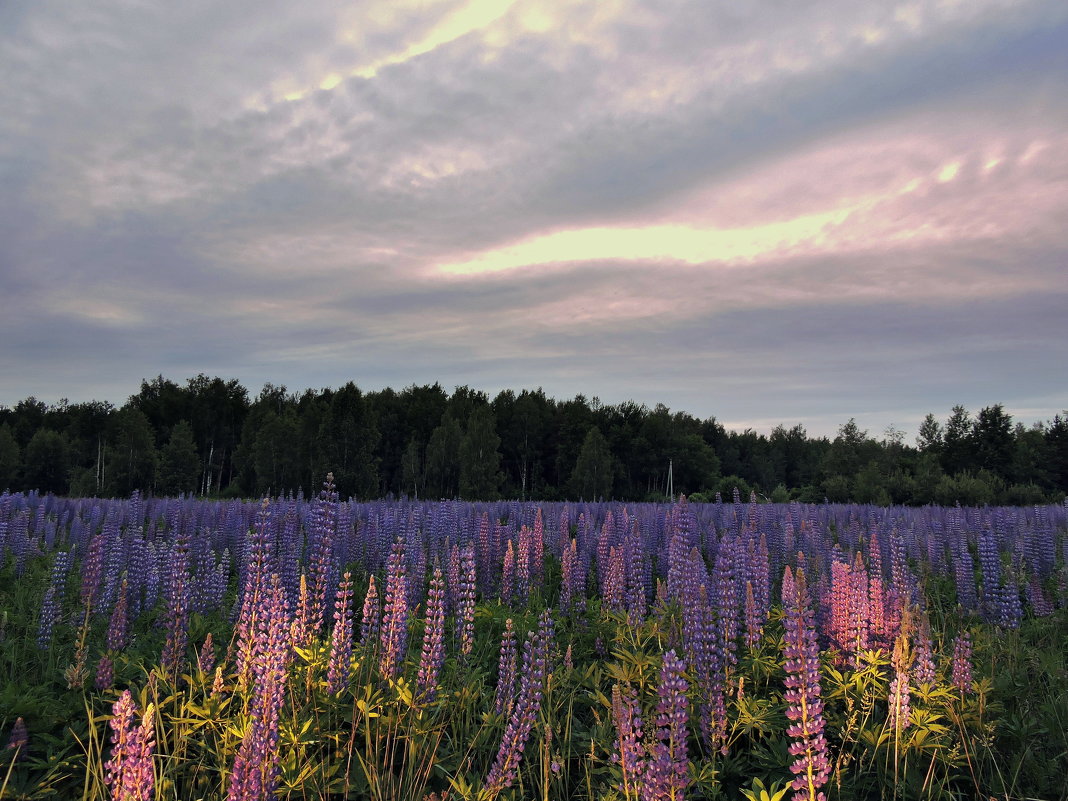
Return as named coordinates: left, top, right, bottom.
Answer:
left=0, top=0, right=1068, bottom=439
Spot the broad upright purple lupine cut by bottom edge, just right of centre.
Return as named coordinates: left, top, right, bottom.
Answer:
left=642, top=650, right=689, bottom=801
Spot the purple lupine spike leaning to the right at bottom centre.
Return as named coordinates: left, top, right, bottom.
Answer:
left=484, top=612, right=551, bottom=799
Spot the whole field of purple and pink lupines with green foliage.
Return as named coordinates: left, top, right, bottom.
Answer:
left=0, top=481, right=1068, bottom=801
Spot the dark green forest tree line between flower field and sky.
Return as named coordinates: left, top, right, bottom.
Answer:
left=0, top=375, right=1068, bottom=504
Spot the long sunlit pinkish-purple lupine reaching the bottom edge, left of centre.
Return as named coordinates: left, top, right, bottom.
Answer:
left=227, top=574, right=290, bottom=801
